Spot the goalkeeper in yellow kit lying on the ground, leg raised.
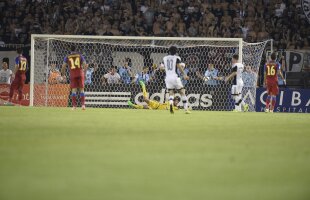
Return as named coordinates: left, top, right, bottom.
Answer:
left=128, top=81, right=179, bottom=110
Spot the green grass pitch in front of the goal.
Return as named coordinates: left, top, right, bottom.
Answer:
left=0, top=107, right=310, bottom=200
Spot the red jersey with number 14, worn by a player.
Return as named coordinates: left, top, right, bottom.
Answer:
left=64, top=52, right=85, bottom=78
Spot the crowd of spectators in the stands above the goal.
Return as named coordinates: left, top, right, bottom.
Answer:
left=0, top=0, right=310, bottom=49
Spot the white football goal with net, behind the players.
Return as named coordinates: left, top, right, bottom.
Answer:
left=30, top=34, right=268, bottom=111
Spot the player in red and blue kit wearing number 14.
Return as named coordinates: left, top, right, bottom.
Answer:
left=61, top=45, right=87, bottom=110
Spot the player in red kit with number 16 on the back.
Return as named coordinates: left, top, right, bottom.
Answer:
left=264, top=53, right=285, bottom=112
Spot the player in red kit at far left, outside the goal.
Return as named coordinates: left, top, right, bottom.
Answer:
left=7, top=49, right=28, bottom=105
